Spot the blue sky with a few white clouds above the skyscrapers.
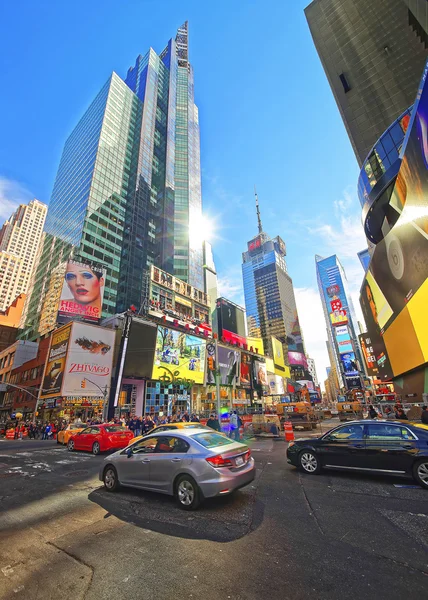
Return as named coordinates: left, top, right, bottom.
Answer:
left=0, top=0, right=365, bottom=380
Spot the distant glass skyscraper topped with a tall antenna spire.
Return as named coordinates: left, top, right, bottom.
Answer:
left=242, top=195, right=309, bottom=380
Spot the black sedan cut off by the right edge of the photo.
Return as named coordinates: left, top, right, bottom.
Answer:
left=287, top=420, right=428, bottom=489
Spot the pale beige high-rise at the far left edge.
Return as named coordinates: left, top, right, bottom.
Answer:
left=0, top=199, right=47, bottom=311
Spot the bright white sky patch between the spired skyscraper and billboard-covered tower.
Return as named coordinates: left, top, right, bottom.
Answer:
left=294, top=288, right=330, bottom=388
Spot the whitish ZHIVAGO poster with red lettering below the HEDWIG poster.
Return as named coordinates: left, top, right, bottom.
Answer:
left=62, top=323, right=115, bottom=398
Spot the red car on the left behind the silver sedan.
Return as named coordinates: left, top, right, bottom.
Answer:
left=67, top=423, right=134, bottom=454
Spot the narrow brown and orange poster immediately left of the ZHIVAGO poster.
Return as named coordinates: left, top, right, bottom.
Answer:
left=40, top=323, right=72, bottom=399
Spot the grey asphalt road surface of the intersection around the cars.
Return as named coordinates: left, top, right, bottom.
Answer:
left=0, top=440, right=428, bottom=600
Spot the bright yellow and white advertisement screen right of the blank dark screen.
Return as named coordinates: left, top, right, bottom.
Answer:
left=152, top=326, right=206, bottom=383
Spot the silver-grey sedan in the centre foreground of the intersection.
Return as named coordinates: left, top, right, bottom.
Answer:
left=99, top=428, right=256, bottom=510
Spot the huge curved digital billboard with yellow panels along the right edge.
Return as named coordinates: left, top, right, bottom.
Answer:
left=360, top=59, right=428, bottom=379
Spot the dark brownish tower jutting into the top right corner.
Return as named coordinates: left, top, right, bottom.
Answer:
left=305, top=0, right=428, bottom=165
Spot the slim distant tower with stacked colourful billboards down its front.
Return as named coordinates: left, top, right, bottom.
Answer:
left=315, top=255, right=364, bottom=389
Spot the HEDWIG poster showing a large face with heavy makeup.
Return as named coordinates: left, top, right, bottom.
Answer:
left=58, top=260, right=106, bottom=325
